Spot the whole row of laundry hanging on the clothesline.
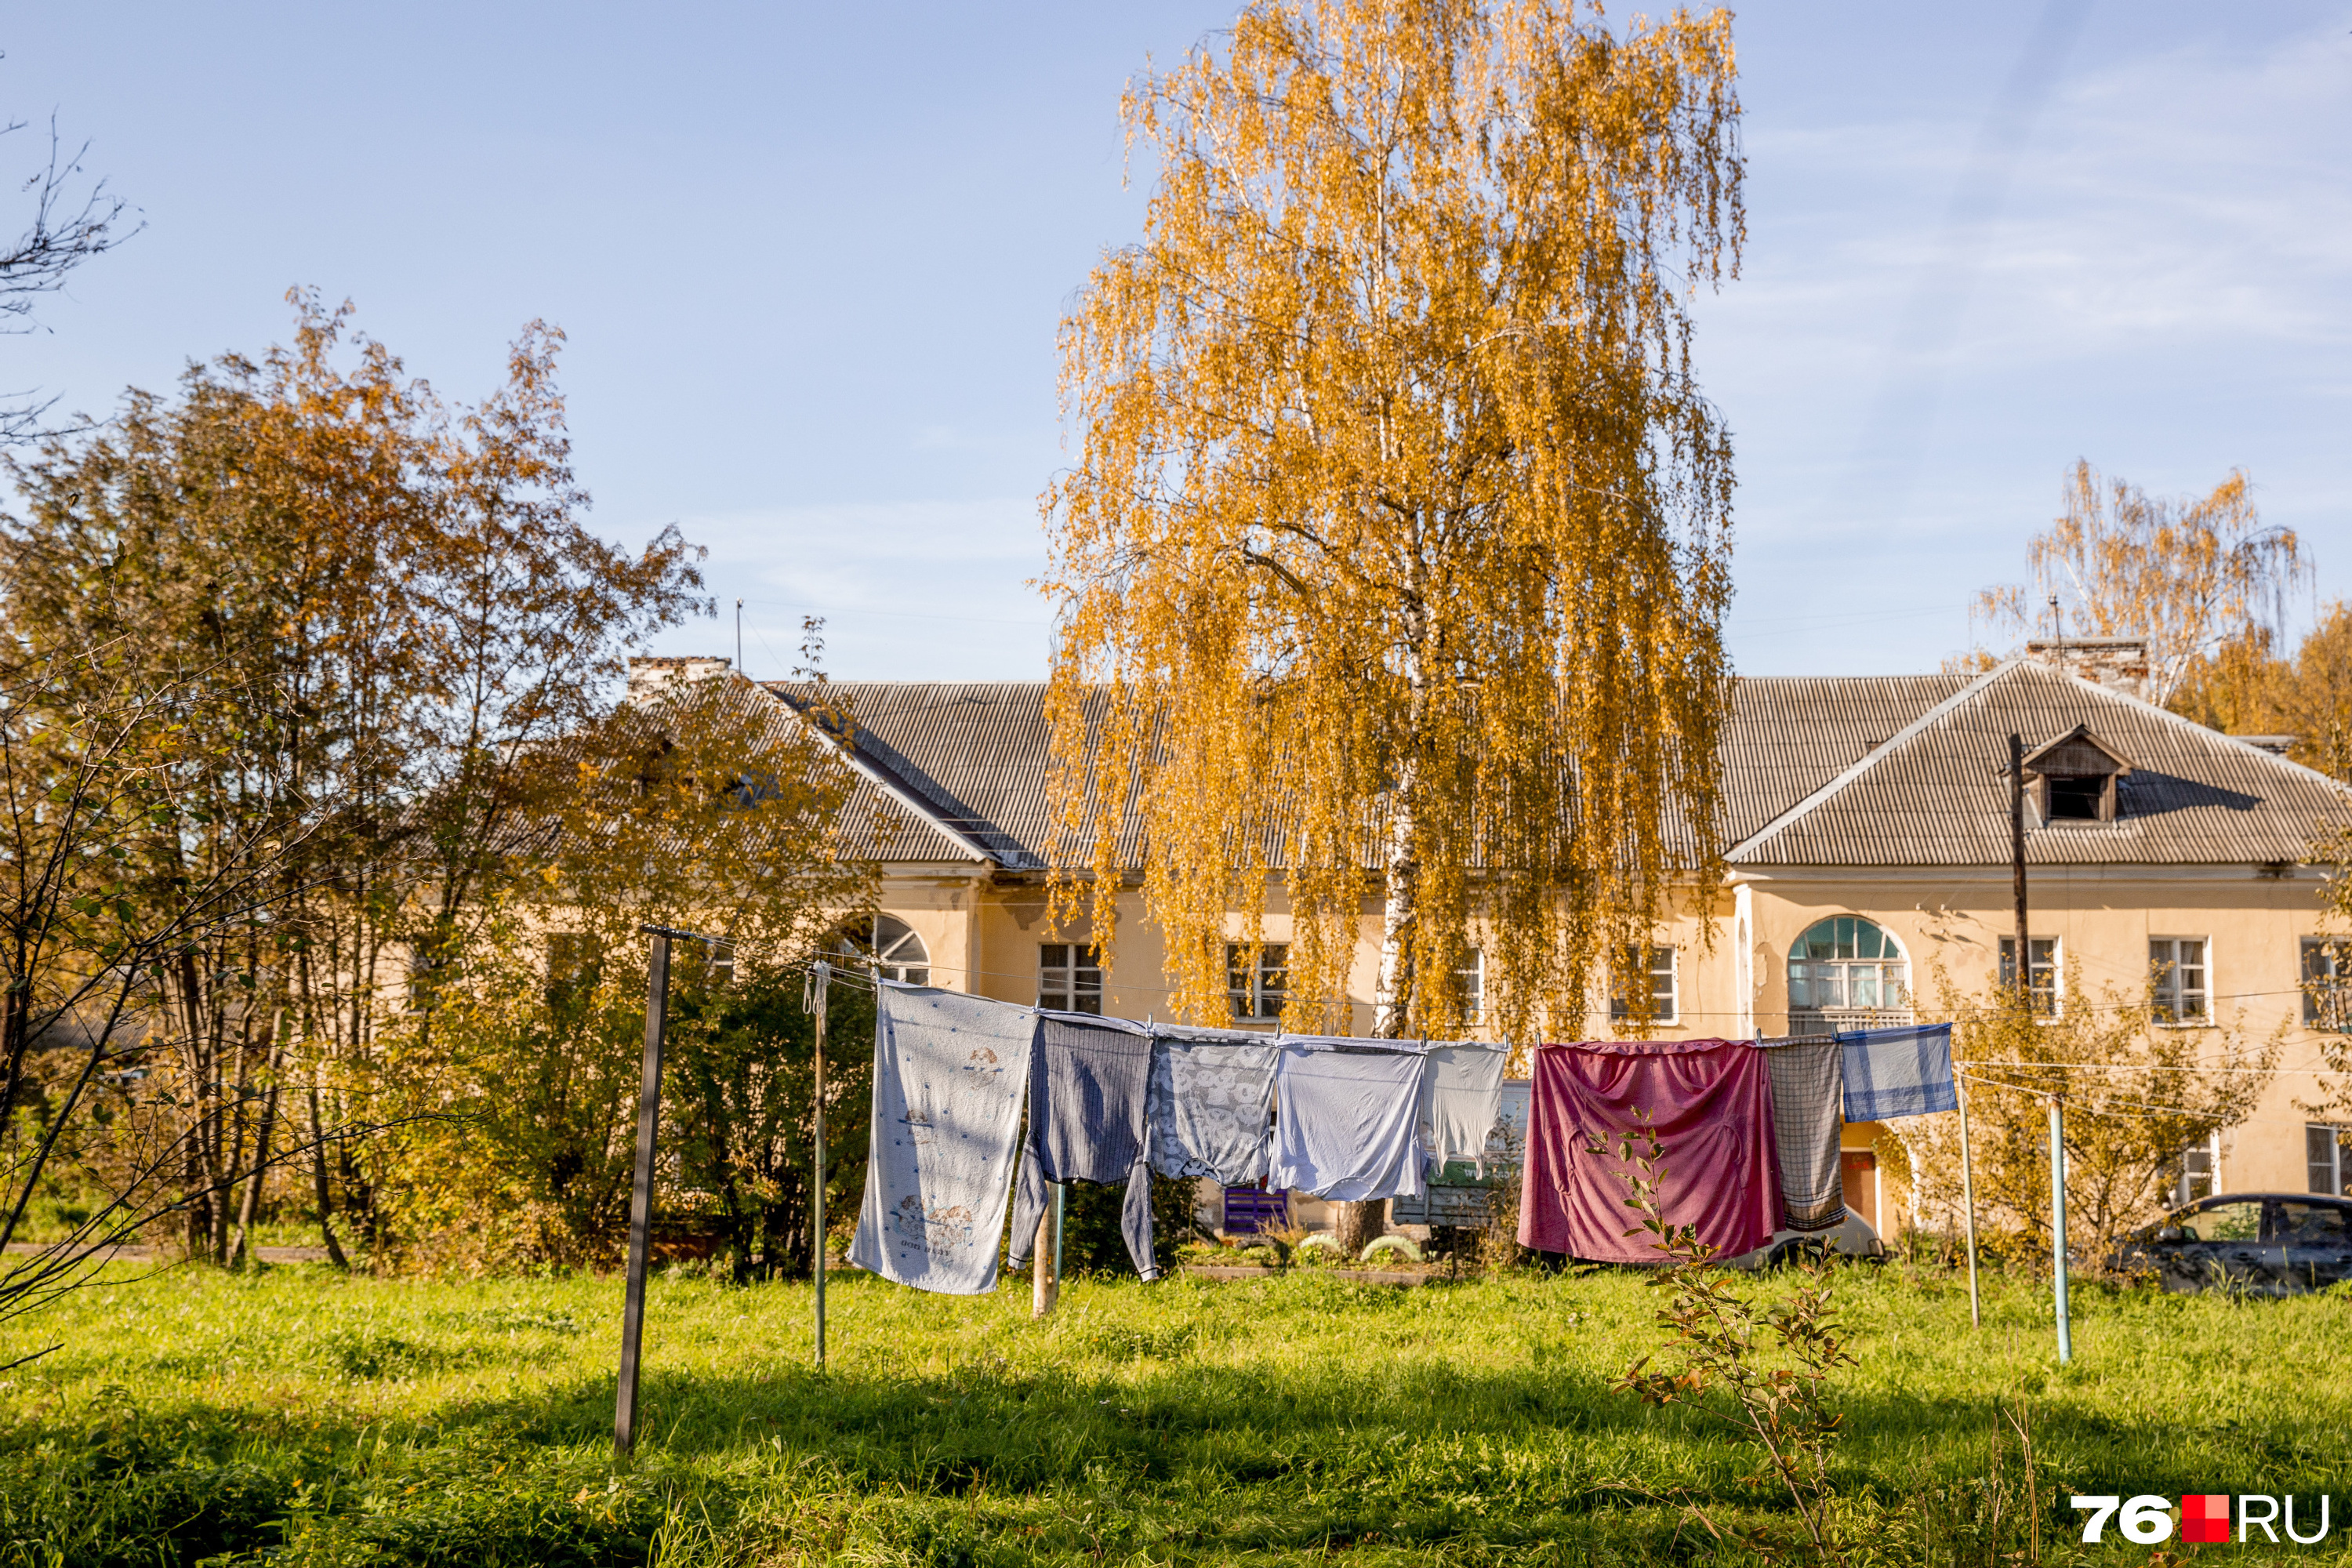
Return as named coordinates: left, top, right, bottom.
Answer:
left=851, top=982, right=1872, bottom=1293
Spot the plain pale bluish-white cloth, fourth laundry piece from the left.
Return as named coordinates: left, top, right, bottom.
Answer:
left=1265, top=1034, right=1428, bottom=1203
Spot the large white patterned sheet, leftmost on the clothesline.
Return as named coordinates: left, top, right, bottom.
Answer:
left=849, top=980, right=1037, bottom=1295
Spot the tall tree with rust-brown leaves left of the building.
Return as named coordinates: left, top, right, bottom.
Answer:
left=0, top=294, right=701, bottom=1260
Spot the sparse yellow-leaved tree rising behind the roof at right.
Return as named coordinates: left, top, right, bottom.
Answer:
left=1971, top=461, right=2310, bottom=706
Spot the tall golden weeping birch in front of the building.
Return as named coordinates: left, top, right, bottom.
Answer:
left=1044, top=0, right=1743, bottom=1227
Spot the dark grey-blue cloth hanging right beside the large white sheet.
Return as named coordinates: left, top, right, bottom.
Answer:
left=1007, top=1013, right=1160, bottom=1279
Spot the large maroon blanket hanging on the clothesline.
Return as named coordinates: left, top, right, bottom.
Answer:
left=1519, top=1039, right=1780, bottom=1262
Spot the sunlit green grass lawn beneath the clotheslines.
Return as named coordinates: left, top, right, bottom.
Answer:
left=0, top=1265, right=2352, bottom=1568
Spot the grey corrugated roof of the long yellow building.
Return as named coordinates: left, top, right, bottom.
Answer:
left=769, top=659, right=2352, bottom=869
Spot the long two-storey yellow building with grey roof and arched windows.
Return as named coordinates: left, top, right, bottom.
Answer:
left=724, top=640, right=2352, bottom=1229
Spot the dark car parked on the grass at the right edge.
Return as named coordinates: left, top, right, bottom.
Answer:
left=2107, top=1192, right=2352, bottom=1295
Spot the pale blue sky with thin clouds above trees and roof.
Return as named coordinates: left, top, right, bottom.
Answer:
left=0, top=0, right=2352, bottom=680
